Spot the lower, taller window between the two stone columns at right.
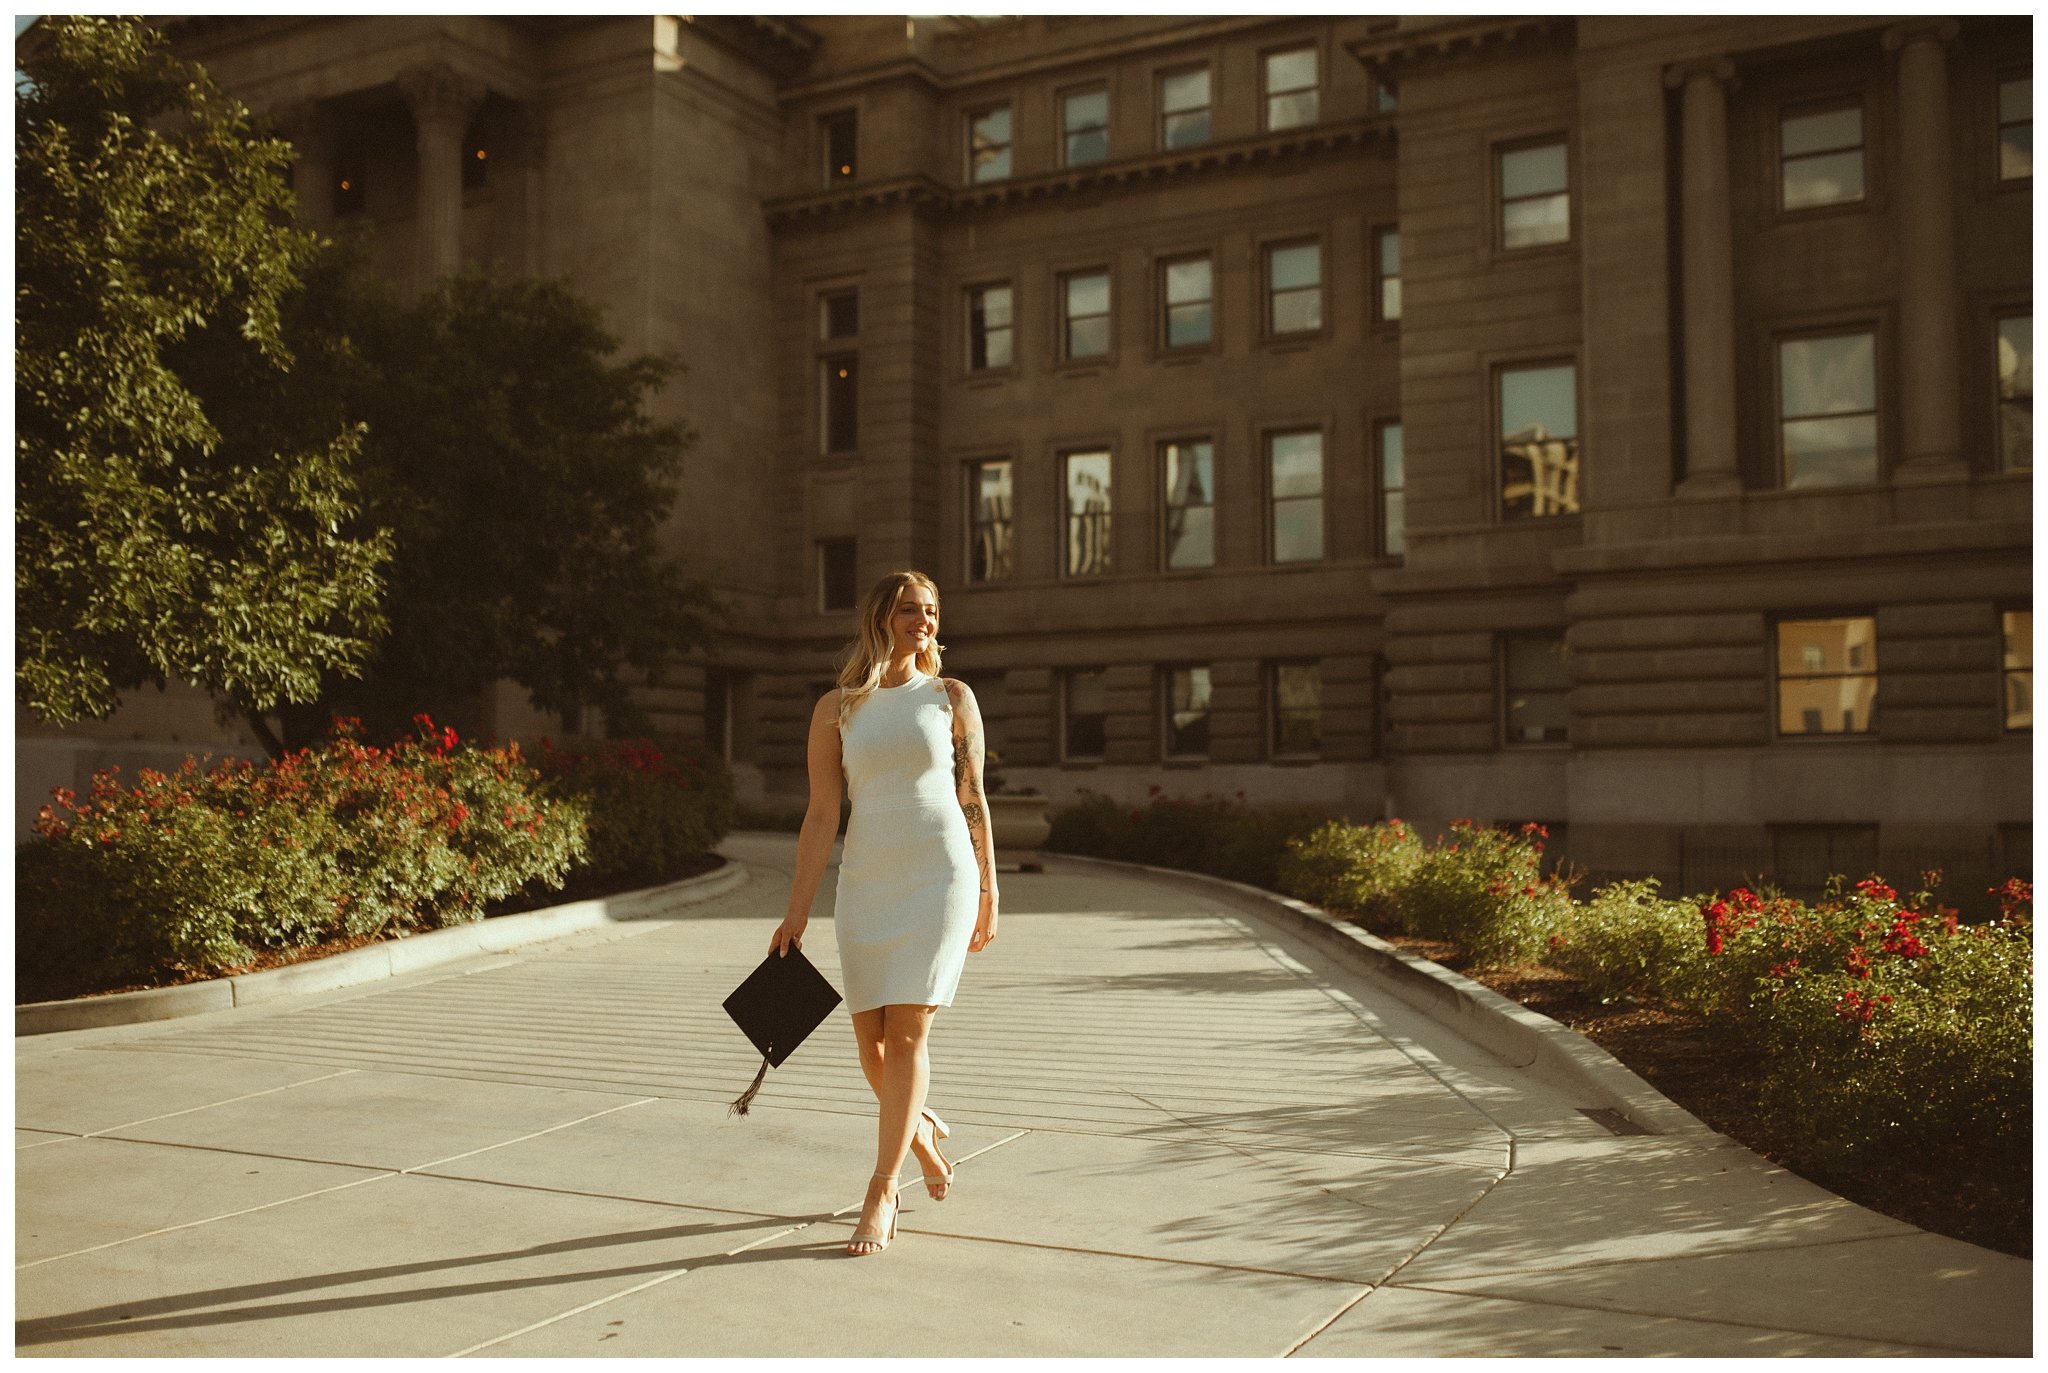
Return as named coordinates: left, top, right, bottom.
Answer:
left=1778, top=334, right=1878, bottom=488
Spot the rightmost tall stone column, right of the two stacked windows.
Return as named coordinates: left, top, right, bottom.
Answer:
left=1884, top=18, right=1968, bottom=484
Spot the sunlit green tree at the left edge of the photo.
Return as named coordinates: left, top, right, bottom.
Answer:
left=14, top=18, right=389, bottom=723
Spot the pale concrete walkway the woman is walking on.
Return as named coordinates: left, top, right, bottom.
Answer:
left=14, top=834, right=2032, bottom=1357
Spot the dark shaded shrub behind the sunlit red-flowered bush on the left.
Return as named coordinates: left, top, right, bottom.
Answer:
left=537, top=740, right=737, bottom=889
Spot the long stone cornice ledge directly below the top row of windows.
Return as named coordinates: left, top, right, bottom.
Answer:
left=762, top=115, right=1395, bottom=227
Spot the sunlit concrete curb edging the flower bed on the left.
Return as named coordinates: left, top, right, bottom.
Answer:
left=14, top=859, right=748, bottom=1035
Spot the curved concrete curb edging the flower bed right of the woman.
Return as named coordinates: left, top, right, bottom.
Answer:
left=1055, top=852, right=1724, bottom=1139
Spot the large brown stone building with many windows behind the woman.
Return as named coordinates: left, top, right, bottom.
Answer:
left=19, top=16, right=2032, bottom=901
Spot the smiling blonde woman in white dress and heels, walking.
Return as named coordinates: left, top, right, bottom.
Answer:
left=768, top=572, right=997, bottom=1256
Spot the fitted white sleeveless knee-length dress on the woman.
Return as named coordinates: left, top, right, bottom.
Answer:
left=831, top=672, right=981, bottom=1010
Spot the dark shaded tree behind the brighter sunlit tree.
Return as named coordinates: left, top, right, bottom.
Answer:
left=213, top=240, right=725, bottom=746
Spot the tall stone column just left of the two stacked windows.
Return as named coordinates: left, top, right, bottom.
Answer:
left=1665, top=57, right=1743, bottom=498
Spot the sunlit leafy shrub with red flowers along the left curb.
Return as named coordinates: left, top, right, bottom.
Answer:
left=16, top=715, right=584, bottom=988
